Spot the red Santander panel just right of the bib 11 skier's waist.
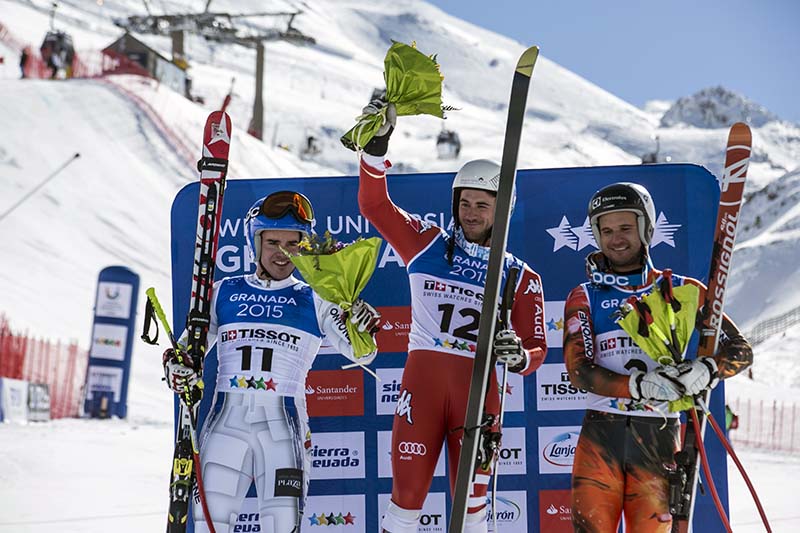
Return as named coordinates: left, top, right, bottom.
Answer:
left=306, top=370, right=364, bottom=416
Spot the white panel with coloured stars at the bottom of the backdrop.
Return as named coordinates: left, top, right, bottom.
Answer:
left=300, top=494, right=366, bottom=533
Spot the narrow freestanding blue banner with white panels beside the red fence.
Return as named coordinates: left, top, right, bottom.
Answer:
left=83, top=266, right=139, bottom=418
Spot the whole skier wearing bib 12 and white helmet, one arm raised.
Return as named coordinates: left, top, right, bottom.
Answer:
left=358, top=95, right=547, bottom=533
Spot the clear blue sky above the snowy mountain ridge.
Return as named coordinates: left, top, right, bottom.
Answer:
left=428, top=0, right=800, bottom=124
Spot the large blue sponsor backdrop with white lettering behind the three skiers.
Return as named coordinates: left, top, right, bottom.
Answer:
left=172, top=165, right=728, bottom=533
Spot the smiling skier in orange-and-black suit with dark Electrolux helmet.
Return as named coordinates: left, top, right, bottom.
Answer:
left=564, top=183, right=753, bottom=533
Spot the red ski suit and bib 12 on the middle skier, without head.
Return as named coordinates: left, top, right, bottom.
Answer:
left=358, top=156, right=547, bottom=527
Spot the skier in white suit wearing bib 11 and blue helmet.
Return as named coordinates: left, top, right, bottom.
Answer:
left=164, top=191, right=379, bottom=533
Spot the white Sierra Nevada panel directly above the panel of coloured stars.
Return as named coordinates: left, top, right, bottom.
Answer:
left=311, top=432, right=364, bottom=479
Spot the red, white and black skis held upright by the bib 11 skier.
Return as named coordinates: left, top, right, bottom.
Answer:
left=142, top=111, right=231, bottom=533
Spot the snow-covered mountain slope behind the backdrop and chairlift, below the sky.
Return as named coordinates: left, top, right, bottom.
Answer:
left=0, top=0, right=800, bottom=341
